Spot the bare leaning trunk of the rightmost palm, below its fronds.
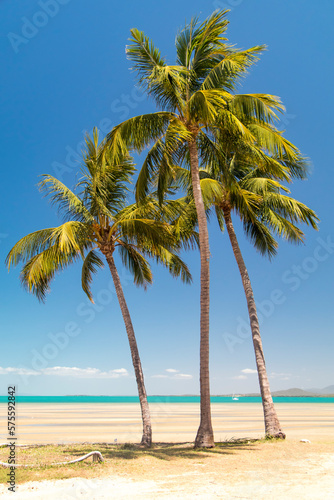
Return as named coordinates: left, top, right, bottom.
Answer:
left=223, top=207, right=285, bottom=439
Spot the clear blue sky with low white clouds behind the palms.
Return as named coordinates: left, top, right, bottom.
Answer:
left=0, top=0, right=334, bottom=395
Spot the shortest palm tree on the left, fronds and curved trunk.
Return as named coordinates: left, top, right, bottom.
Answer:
left=6, top=129, right=192, bottom=446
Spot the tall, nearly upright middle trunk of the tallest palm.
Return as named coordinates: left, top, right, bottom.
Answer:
left=188, top=140, right=215, bottom=448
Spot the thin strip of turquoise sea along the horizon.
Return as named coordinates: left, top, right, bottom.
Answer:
left=0, top=396, right=334, bottom=404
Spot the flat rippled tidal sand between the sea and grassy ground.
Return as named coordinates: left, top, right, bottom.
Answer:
left=0, top=402, right=334, bottom=444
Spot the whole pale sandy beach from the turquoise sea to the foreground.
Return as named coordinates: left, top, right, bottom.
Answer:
left=0, top=403, right=334, bottom=500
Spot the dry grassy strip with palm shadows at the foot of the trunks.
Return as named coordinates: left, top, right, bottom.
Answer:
left=0, top=439, right=333, bottom=484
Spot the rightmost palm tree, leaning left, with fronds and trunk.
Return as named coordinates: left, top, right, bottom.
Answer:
left=196, top=137, right=318, bottom=439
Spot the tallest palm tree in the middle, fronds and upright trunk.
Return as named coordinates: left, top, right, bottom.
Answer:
left=106, top=11, right=282, bottom=447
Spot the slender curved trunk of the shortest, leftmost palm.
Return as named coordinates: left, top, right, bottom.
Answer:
left=103, top=251, right=152, bottom=447
